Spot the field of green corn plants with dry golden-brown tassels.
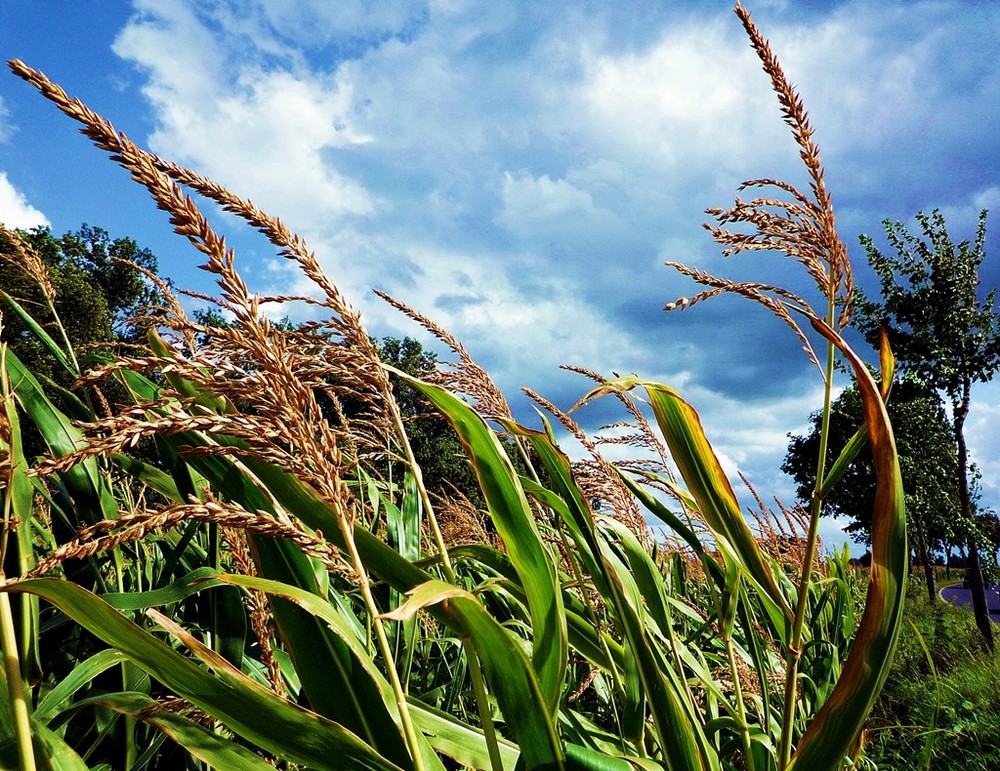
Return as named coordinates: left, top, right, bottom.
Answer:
left=0, top=6, right=907, bottom=771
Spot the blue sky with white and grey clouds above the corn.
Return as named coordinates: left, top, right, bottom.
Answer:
left=0, top=0, right=1000, bottom=556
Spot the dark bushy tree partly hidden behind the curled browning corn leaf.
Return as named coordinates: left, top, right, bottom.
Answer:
left=781, top=377, right=961, bottom=602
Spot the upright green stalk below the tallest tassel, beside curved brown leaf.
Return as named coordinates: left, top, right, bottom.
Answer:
left=778, top=289, right=837, bottom=769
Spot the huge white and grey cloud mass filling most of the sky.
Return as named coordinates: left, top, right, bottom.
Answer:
left=103, top=0, right=1000, bottom=536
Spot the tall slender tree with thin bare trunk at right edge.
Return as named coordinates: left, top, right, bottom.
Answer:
left=857, top=210, right=1000, bottom=650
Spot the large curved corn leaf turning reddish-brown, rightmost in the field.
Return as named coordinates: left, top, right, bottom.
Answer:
left=789, top=319, right=908, bottom=771
